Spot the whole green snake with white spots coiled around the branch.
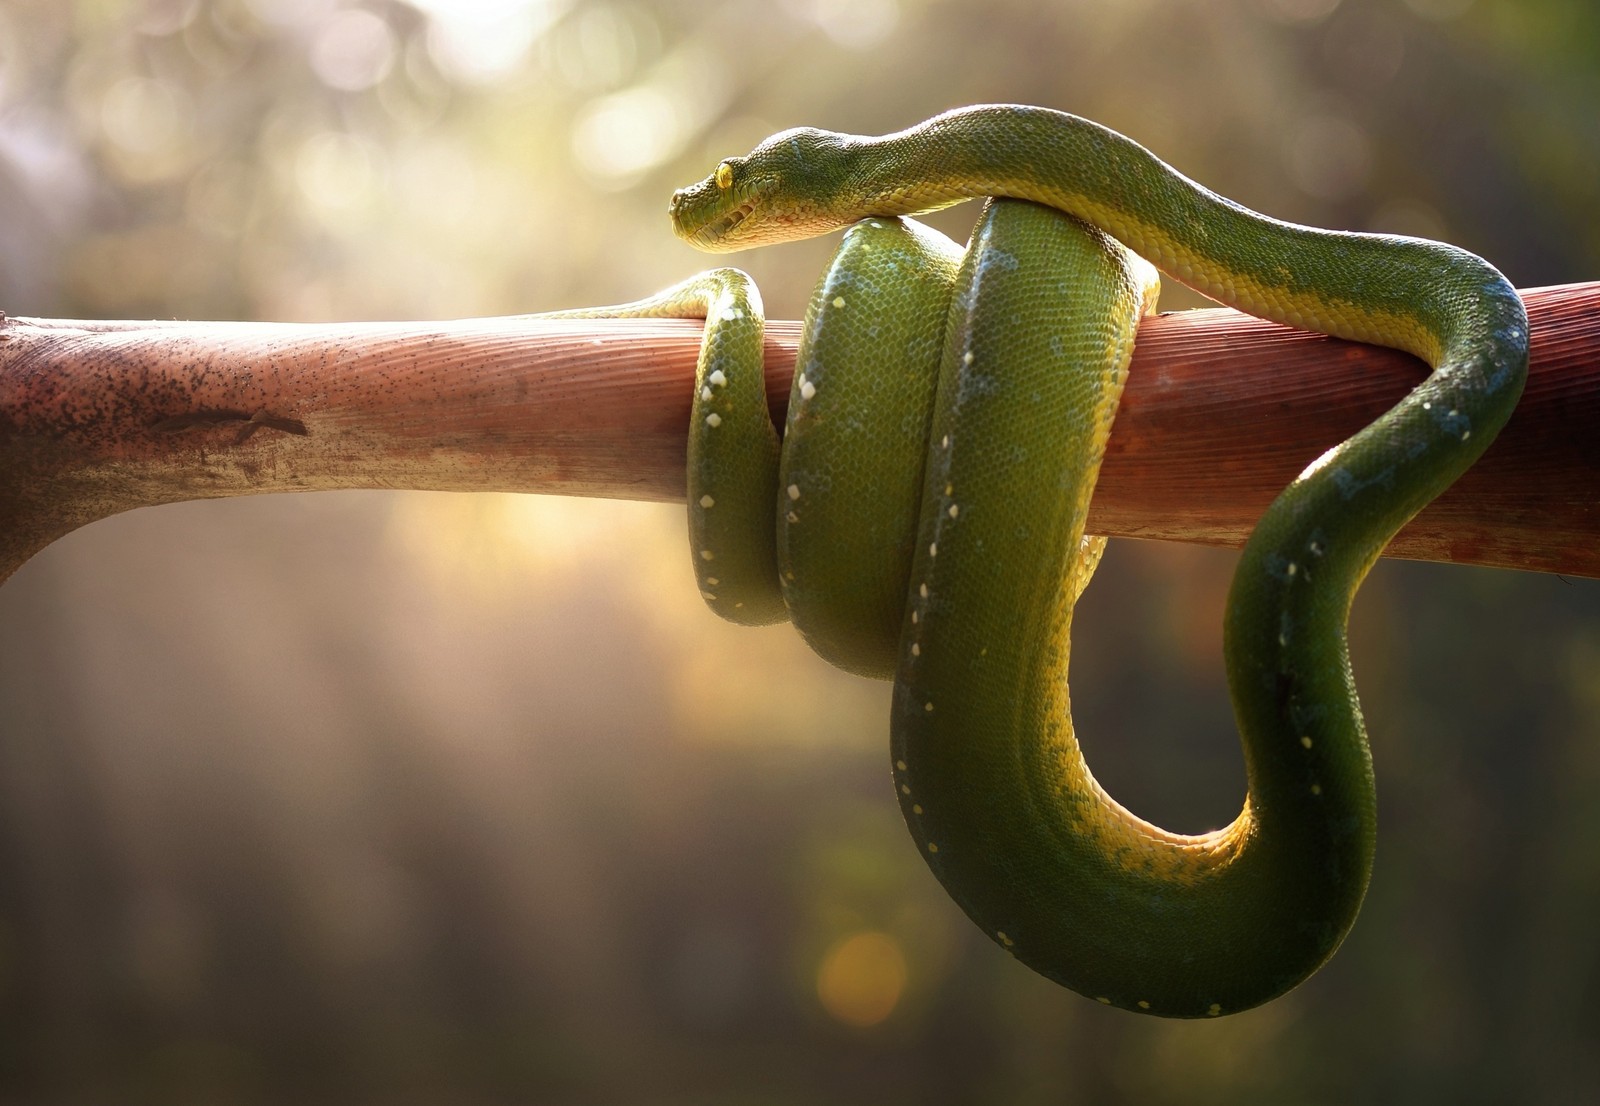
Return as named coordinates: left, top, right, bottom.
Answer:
left=547, top=106, right=1528, bottom=1018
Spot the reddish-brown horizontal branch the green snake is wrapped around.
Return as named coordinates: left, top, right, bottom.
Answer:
left=0, top=283, right=1600, bottom=579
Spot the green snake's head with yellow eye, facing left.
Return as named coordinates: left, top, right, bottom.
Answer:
left=667, top=126, right=853, bottom=253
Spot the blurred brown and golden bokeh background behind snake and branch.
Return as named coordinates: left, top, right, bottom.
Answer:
left=0, top=0, right=1600, bottom=1104
